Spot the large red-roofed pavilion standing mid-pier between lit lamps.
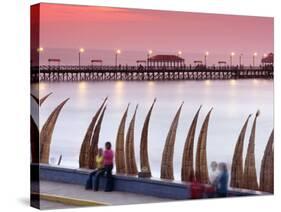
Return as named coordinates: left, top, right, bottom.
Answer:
left=147, top=55, right=185, bottom=67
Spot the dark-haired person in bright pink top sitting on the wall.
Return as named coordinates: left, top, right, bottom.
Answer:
left=94, top=141, right=114, bottom=192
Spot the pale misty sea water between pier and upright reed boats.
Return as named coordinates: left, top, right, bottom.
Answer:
left=34, top=80, right=273, bottom=179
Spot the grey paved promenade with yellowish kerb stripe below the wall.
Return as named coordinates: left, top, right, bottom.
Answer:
left=40, top=181, right=173, bottom=209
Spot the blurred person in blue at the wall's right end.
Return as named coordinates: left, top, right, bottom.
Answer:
left=215, top=163, right=229, bottom=197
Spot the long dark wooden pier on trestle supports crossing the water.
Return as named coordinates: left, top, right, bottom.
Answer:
left=31, top=65, right=274, bottom=82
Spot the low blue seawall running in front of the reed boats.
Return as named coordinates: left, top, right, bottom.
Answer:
left=34, top=164, right=268, bottom=200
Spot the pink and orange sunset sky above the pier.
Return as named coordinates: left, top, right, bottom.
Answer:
left=32, top=4, right=274, bottom=64
